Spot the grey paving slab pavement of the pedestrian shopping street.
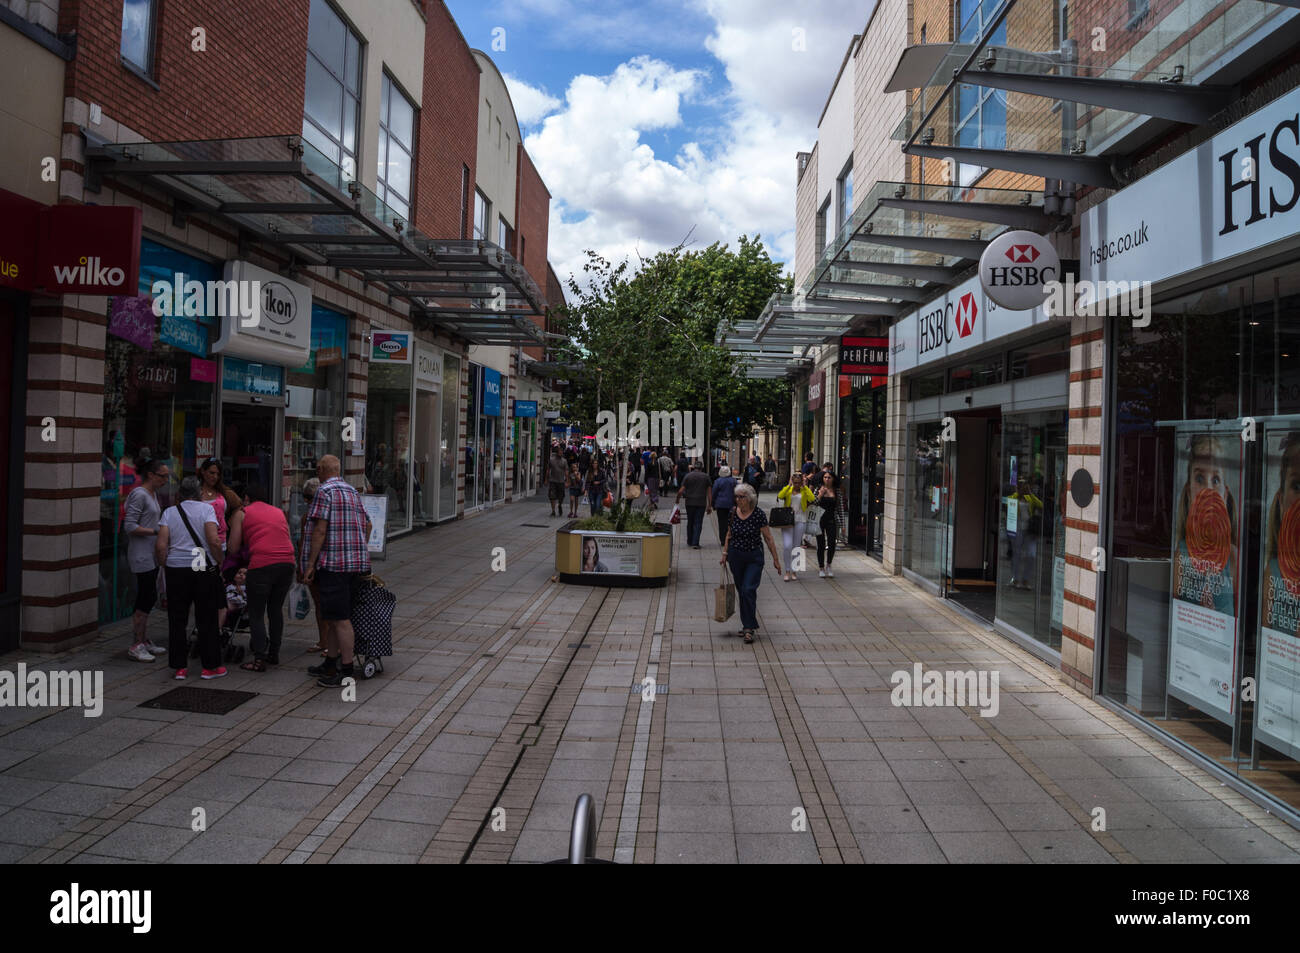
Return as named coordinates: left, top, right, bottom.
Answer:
left=0, top=499, right=1300, bottom=863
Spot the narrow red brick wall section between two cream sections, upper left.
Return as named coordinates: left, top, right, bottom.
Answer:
left=415, top=0, right=478, bottom=239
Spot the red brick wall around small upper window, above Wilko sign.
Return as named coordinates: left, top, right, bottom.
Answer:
left=59, top=0, right=311, bottom=142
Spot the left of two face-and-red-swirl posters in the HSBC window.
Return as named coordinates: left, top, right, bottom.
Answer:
left=1169, top=432, right=1242, bottom=722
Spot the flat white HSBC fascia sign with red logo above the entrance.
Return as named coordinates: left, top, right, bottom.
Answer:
left=889, top=271, right=1049, bottom=374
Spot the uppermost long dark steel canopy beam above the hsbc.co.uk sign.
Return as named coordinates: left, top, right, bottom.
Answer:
left=961, top=69, right=1232, bottom=126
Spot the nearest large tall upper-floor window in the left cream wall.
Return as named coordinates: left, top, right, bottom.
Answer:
left=303, top=0, right=361, bottom=178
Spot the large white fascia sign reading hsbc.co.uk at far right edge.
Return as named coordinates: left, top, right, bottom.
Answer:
left=1079, top=88, right=1300, bottom=282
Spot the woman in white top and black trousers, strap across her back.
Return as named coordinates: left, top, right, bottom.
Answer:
left=155, top=477, right=226, bottom=679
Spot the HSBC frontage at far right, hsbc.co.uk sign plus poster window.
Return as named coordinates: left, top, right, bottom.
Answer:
left=1082, top=91, right=1300, bottom=816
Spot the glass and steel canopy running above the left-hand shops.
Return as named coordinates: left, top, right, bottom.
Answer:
left=86, top=133, right=546, bottom=345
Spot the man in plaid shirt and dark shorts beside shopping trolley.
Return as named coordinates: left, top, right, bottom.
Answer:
left=303, top=454, right=371, bottom=688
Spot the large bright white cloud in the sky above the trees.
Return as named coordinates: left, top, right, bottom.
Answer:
left=511, top=0, right=874, bottom=289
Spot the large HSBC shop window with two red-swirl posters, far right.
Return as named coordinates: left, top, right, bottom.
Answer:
left=1101, top=260, right=1300, bottom=809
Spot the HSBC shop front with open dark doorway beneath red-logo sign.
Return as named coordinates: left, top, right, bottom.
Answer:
left=889, top=271, right=1070, bottom=658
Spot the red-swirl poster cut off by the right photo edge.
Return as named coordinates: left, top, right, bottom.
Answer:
left=1255, top=429, right=1300, bottom=758
